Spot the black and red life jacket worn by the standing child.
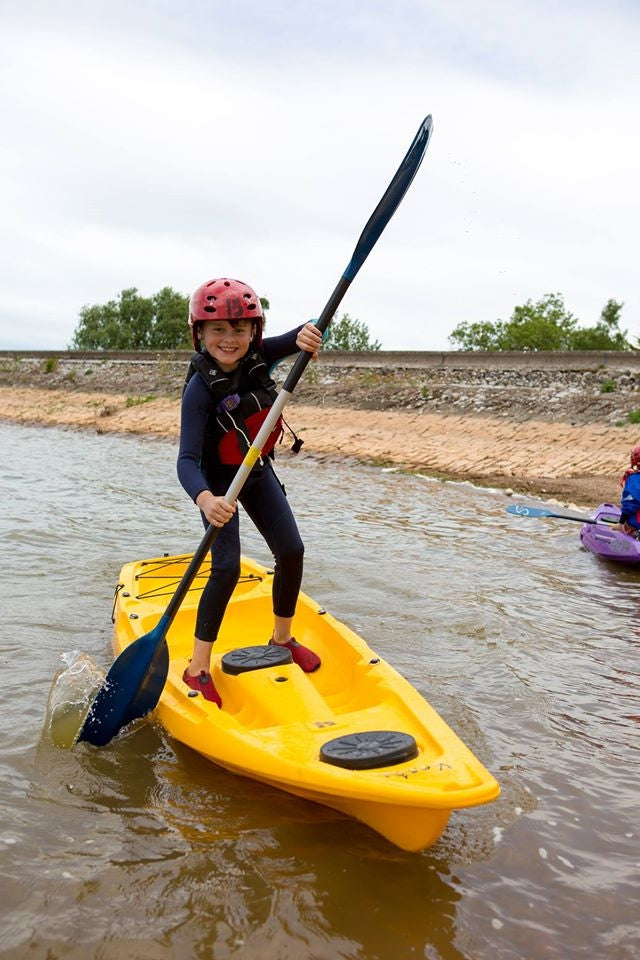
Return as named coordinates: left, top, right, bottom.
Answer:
left=183, top=350, right=283, bottom=464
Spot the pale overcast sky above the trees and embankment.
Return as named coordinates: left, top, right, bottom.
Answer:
left=0, top=0, right=640, bottom=350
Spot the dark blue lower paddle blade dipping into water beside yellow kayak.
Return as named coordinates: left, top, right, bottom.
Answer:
left=78, top=622, right=169, bottom=747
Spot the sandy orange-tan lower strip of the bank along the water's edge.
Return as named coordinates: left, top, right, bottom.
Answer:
left=0, top=387, right=638, bottom=507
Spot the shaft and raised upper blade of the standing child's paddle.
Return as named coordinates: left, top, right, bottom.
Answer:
left=162, top=116, right=433, bottom=632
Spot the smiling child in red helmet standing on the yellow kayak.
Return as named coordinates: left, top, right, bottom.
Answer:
left=178, top=279, right=322, bottom=707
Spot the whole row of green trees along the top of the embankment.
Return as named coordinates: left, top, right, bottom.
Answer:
left=71, top=287, right=638, bottom=351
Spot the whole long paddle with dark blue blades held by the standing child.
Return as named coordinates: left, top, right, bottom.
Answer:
left=78, top=116, right=433, bottom=746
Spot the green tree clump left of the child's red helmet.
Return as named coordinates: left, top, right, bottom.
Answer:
left=71, top=287, right=192, bottom=350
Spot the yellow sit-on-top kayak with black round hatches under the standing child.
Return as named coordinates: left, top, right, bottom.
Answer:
left=114, top=556, right=500, bottom=851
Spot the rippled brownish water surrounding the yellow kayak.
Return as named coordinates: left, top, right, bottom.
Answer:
left=0, top=424, right=640, bottom=960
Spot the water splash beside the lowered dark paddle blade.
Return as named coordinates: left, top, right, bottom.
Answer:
left=43, top=650, right=104, bottom=749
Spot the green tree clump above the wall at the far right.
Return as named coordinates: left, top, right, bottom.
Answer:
left=449, top=293, right=633, bottom=350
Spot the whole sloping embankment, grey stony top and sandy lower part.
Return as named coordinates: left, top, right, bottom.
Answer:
left=0, top=355, right=640, bottom=507
